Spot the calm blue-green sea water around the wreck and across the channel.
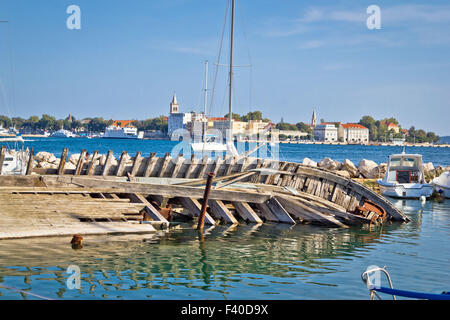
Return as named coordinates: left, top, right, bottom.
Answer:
left=0, top=139, right=450, bottom=299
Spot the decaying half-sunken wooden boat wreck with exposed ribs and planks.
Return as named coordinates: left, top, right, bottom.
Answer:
left=0, top=149, right=409, bottom=238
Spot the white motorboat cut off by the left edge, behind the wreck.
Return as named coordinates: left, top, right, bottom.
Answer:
left=0, top=137, right=28, bottom=175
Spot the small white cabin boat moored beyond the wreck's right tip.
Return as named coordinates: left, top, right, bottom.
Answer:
left=377, top=153, right=433, bottom=198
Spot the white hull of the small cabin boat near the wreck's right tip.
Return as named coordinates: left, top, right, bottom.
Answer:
left=377, top=180, right=433, bottom=199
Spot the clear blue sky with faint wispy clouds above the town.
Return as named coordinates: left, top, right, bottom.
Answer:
left=0, top=0, right=450, bottom=135
